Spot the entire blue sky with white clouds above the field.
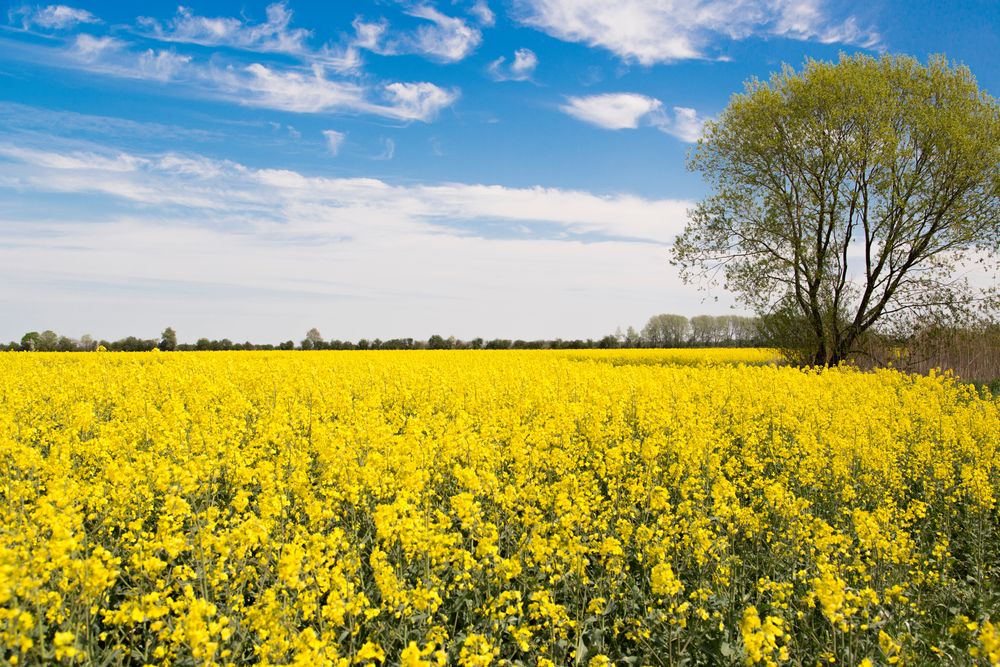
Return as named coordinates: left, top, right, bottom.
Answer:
left=0, top=0, right=1000, bottom=342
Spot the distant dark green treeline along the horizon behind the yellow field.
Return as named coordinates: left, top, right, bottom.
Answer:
left=5, top=314, right=761, bottom=352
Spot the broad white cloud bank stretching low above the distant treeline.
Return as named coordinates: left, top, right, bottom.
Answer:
left=0, top=140, right=701, bottom=341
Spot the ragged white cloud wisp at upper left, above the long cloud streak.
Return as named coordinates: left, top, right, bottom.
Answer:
left=139, top=2, right=312, bottom=55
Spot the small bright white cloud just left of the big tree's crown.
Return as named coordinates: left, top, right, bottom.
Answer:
left=559, top=93, right=705, bottom=143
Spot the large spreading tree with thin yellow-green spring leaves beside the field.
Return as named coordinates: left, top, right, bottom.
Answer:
left=672, top=55, right=1000, bottom=365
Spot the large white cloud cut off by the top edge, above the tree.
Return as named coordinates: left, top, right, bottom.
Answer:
left=515, top=0, right=879, bottom=65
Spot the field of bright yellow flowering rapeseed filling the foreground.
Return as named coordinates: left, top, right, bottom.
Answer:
left=0, top=350, right=1000, bottom=666
